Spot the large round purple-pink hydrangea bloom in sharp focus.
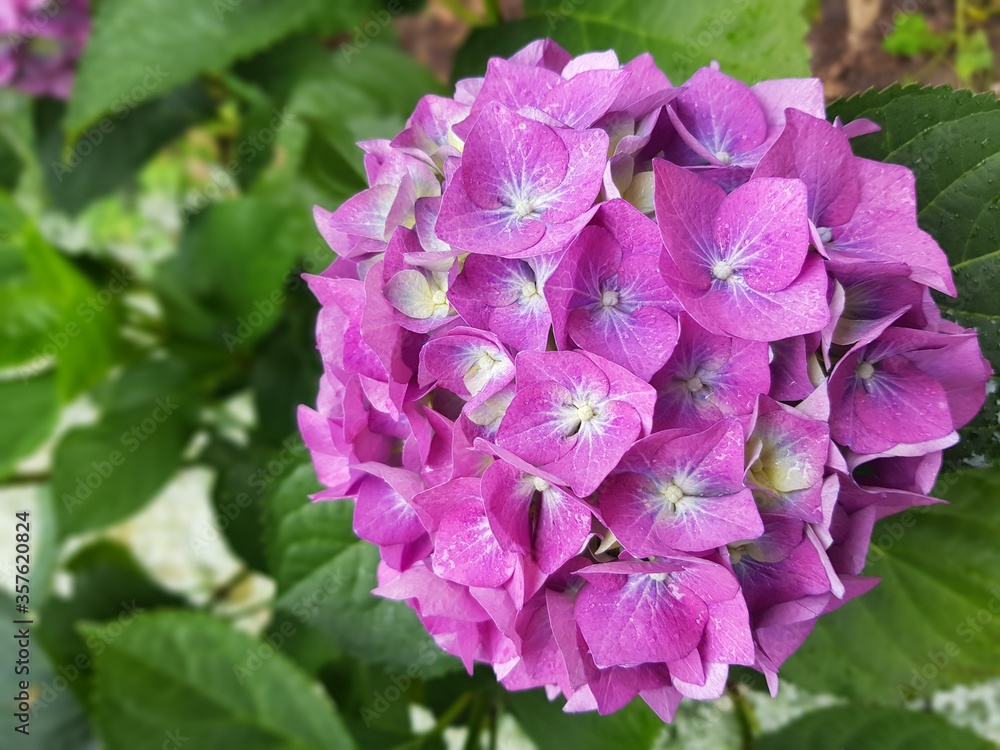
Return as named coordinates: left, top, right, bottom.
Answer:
left=300, top=41, right=990, bottom=720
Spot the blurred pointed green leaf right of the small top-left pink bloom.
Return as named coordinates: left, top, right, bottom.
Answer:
left=67, top=0, right=382, bottom=130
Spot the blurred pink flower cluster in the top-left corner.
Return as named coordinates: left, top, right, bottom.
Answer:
left=0, top=0, right=90, bottom=99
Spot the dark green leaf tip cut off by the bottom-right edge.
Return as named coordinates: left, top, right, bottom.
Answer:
left=754, top=704, right=996, bottom=750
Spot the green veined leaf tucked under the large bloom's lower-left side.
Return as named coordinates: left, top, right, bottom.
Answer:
left=268, top=466, right=458, bottom=677
